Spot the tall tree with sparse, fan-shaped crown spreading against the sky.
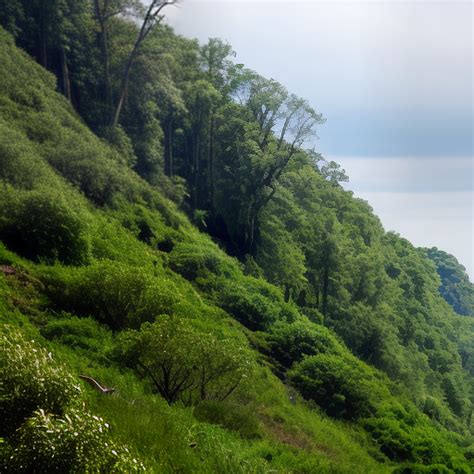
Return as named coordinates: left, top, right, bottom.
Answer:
left=216, top=70, right=324, bottom=254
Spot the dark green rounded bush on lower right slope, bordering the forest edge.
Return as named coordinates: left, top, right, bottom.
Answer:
left=288, top=354, right=377, bottom=419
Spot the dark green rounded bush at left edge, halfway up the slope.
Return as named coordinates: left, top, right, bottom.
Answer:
left=0, top=186, right=89, bottom=265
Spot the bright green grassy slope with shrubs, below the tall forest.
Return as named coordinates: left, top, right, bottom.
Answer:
left=0, top=26, right=472, bottom=473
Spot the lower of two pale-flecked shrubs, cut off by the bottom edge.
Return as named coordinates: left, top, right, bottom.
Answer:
left=7, top=409, right=145, bottom=473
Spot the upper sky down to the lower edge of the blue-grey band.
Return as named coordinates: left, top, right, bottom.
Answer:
left=166, top=0, right=473, bottom=156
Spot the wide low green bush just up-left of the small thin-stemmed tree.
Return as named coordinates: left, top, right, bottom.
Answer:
left=44, top=260, right=179, bottom=330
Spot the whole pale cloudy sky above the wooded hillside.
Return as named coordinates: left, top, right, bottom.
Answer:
left=166, top=0, right=474, bottom=281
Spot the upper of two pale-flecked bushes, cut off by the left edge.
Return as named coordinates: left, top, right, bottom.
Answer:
left=0, top=326, right=80, bottom=435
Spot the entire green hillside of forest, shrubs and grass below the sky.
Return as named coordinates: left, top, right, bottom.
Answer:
left=0, top=0, right=474, bottom=474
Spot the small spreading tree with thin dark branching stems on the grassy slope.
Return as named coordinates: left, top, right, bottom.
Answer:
left=119, top=316, right=251, bottom=404
